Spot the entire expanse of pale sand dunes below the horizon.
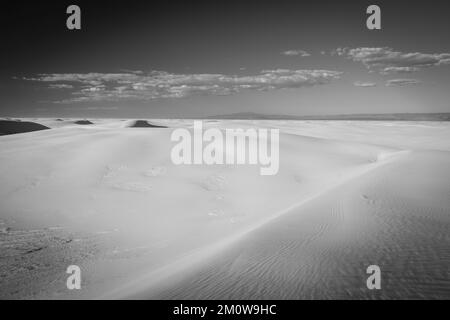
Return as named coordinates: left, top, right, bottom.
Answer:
left=0, top=119, right=450, bottom=299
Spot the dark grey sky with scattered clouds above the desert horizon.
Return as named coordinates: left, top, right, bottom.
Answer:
left=0, top=0, right=450, bottom=118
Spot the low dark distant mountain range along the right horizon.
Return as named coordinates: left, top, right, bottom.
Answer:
left=208, top=112, right=450, bottom=121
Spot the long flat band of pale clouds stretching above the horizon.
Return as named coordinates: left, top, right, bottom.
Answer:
left=23, top=69, right=342, bottom=103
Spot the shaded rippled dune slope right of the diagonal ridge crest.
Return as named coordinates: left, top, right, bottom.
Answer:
left=139, top=153, right=450, bottom=299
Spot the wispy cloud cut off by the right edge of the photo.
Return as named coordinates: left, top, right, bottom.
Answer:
left=333, top=47, right=450, bottom=74
